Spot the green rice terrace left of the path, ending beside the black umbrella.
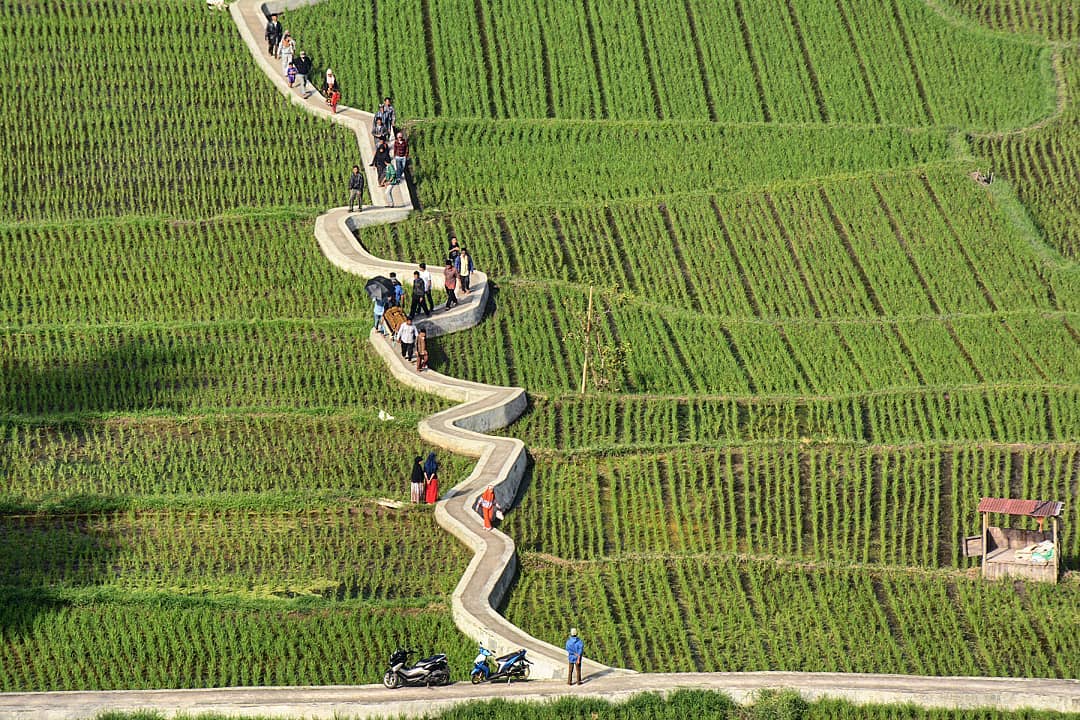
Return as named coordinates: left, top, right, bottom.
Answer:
left=0, top=214, right=380, bottom=327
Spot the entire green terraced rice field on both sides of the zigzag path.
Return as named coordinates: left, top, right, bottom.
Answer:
left=0, top=0, right=1080, bottom=690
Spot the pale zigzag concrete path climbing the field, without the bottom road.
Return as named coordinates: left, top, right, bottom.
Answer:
left=230, top=0, right=612, bottom=679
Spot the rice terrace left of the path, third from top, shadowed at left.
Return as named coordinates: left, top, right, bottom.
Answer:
left=0, top=318, right=442, bottom=417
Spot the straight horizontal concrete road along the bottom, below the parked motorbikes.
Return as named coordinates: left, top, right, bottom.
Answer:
left=0, top=673, right=1080, bottom=720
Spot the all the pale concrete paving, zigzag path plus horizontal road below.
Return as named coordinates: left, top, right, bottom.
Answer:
left=0, top=0, right=1080, bottom=720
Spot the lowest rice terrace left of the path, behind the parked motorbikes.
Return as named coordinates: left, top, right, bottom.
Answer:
left=0, top=595, right=475, bottom=692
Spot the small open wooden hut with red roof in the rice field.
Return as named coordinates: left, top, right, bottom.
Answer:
left=963, top=498, right=1065, bottom=583
